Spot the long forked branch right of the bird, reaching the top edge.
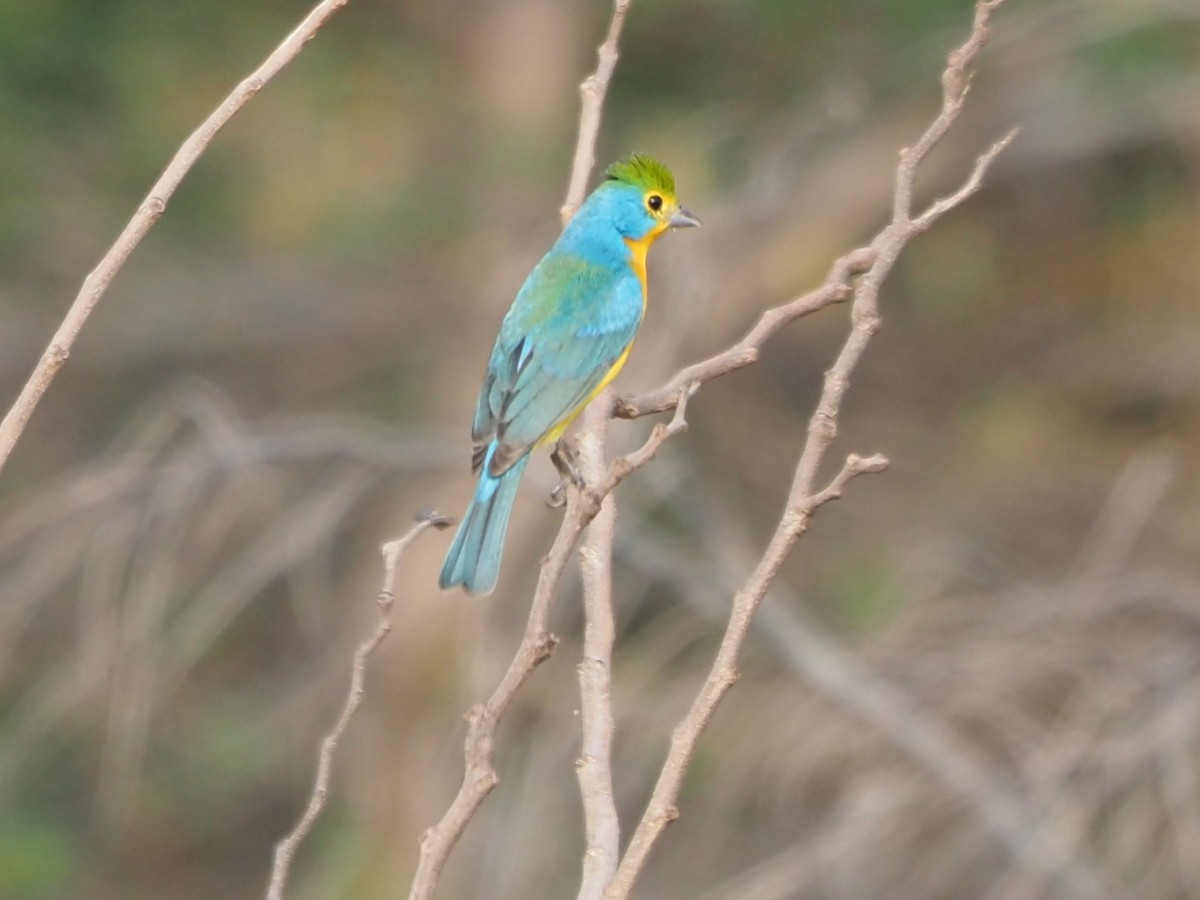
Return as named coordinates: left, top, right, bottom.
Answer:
left=605, top=0, right=1013, bottom=900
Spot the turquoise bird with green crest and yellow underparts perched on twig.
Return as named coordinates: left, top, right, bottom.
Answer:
left=438, top=154, right=700, bottom=596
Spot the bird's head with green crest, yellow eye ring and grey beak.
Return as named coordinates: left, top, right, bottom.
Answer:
left=576, top=154, right=700, bottom=242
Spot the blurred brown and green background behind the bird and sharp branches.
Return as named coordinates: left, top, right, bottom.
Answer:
left=0, top=0, right=1200, bottom=900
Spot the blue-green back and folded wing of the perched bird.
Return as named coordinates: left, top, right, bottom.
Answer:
left=472, top=252, right=643, bottom=475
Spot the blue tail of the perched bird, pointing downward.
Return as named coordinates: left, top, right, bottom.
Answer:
left=438, top=448, right=529, bottom=595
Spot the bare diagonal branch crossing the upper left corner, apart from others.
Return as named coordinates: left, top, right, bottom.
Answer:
left=0, top=0, right=348, bottom=487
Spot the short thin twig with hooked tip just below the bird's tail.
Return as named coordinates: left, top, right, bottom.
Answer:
left=266, top=512, right=451, bottom=900
